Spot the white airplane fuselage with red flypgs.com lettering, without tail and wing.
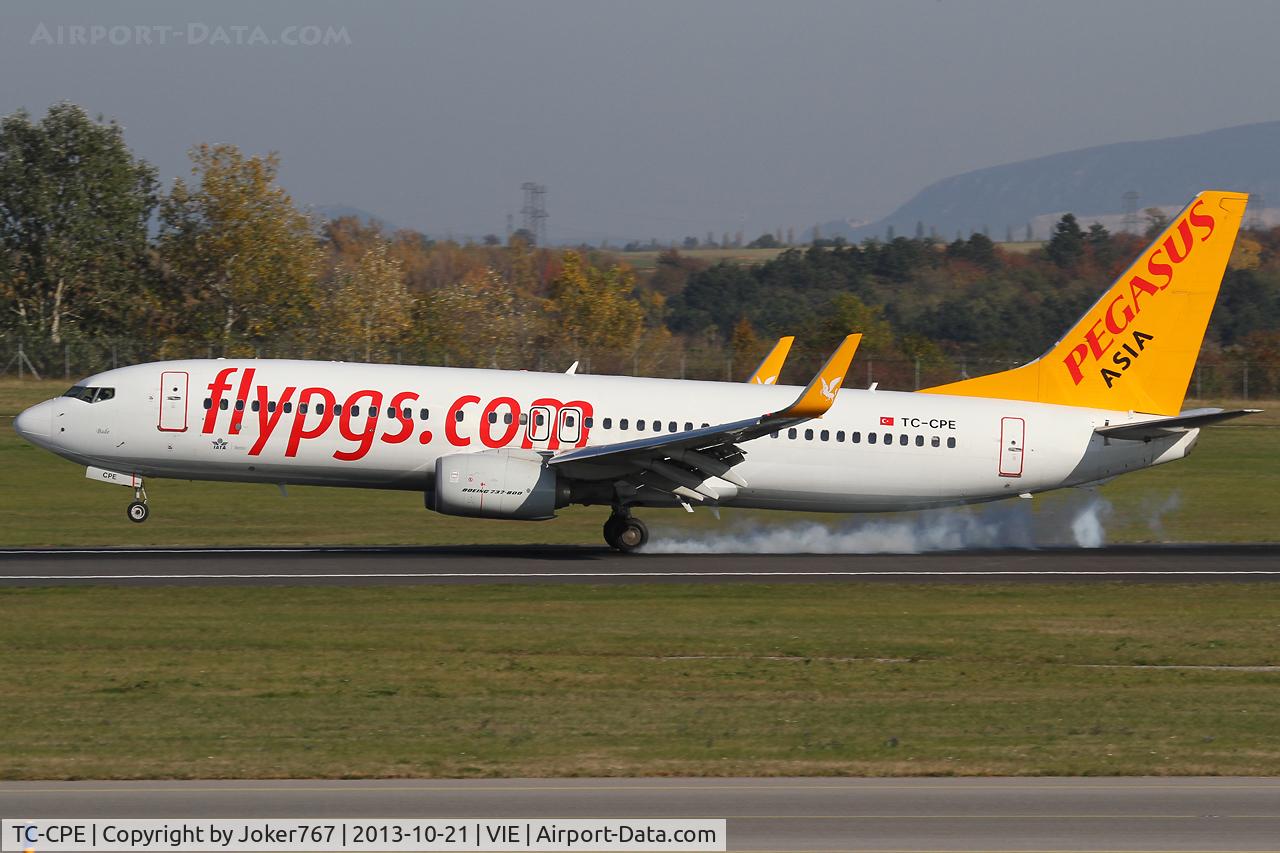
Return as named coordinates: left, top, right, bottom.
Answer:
left=12, top=360, right=1197, bottom=512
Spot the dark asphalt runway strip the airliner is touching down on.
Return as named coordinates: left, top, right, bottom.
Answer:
left=0, top=544, right=1280, bottom=587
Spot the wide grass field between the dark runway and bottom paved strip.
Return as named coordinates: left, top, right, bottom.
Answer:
left=0, top=584, right=1280, bottom=779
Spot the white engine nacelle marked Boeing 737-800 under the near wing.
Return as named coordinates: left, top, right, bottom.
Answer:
left=426, top=450, right=568, bottom=521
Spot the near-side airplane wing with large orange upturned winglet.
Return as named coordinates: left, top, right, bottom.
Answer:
left=548, top=334, right=863, bottom=501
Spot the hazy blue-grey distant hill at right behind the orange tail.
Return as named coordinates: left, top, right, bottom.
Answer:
left=819, top=122, right=1280, bottom=242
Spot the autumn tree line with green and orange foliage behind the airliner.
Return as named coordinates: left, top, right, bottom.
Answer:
left=0, top=104, right=1280, bottom=384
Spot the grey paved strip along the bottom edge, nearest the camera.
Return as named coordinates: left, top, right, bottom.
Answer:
left=0, top=777, right=1280, bottom=853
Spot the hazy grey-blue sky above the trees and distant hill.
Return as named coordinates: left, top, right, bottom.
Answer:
left=0, top=0, right=1280, bottom=242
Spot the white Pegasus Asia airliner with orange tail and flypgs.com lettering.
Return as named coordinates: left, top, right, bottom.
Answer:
left=14, top=192, right=1252, bottom=551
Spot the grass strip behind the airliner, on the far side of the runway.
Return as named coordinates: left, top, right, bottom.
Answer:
left=0, top=379, right=1280, bottom=546
